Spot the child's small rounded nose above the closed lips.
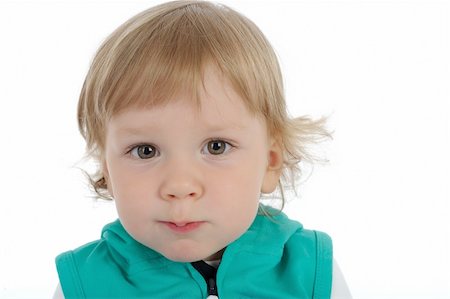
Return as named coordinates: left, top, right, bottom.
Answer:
left=160, top=159, right=203, bottom=200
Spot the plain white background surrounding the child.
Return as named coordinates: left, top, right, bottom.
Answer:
left=0, top=0, right=450, bottom=299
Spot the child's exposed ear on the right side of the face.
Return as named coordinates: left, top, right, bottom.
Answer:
left=261, top=139, right=283, bottom=193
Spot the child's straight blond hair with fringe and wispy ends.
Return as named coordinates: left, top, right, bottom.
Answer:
left=78, top=1, right=329, bottom=204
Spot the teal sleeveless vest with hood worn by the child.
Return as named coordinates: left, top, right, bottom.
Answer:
left=56, top=213, right=332, bottom=299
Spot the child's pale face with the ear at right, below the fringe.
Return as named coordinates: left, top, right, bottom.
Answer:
left=104, top=68, right=281, bottom=262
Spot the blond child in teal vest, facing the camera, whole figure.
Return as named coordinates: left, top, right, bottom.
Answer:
left=56, top=1, right=352, bottom=298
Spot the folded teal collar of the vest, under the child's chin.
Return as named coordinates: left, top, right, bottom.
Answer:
left=102, top=207, right=302, bottom=274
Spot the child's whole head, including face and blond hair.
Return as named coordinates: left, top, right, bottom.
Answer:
left=78, top=1, right=325, bottom=261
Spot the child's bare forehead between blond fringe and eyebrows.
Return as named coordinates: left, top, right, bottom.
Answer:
left=110, top=67, right=263, bottom=133
